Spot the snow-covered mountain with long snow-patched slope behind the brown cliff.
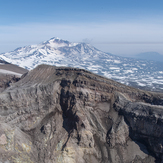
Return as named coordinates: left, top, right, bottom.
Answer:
left=0, top=38, right=163, bottom=92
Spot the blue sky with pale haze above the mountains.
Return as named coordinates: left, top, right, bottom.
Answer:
left=0, top=0, right=163, bottom=55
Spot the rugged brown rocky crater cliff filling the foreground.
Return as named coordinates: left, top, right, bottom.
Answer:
left=0, top=65, right=163, bottom=163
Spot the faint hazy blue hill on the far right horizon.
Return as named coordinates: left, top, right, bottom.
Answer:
left=134, top=52, right=163, bottom=62
